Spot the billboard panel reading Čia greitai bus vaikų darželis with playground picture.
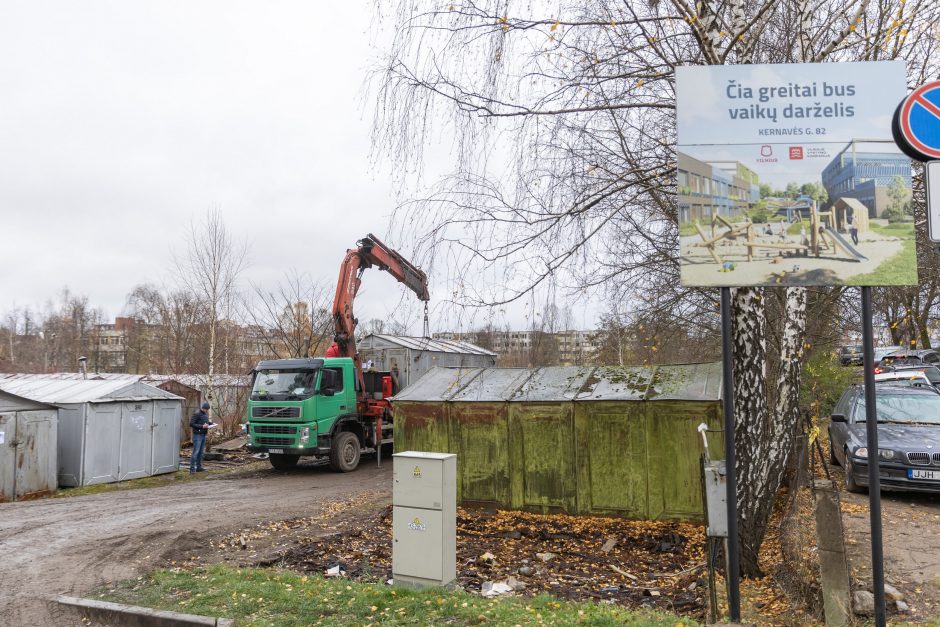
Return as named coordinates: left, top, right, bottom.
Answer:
left=676, top=61, right=917, bottom=287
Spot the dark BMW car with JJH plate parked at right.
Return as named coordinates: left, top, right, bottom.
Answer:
left=829, top=385, right=940, bottom=492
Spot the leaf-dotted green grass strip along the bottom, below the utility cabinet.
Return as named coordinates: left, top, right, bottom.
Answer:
left=96, top=565, right=697, bottom=627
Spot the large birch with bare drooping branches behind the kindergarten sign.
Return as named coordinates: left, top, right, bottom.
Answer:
left=375, top=0, right=938, bottom=575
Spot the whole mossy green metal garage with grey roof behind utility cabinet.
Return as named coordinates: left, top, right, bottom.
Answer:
left=393, top=363, right=722, bottom=520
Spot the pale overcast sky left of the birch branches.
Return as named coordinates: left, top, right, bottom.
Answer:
left=0, top=0, right=596, bottom=332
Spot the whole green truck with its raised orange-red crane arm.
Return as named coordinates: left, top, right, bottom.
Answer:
left=246, top=233, right=430, bottom=472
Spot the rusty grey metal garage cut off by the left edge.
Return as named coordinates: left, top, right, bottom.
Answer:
left=0, top=390, right=58, bottom=503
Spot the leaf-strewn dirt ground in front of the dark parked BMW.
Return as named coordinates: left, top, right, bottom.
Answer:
left=835, top=486, right=940, bottom=620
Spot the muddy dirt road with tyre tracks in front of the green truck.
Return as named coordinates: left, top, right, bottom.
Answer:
left=0, top=460, right=392, bottom=626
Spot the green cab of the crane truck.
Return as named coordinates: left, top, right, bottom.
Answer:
left=246, top=357, right=366, bottom=472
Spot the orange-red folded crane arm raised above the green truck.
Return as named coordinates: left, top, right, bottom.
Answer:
left=333, top=233, right=431, bottom=398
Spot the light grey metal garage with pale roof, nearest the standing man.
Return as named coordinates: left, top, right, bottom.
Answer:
left=0, top=375, right=182, bottom=486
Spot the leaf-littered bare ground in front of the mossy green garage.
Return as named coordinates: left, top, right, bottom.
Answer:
left=265, top=507, right=707, bottom=617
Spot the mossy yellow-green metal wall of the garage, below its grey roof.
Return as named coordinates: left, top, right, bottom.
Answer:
left=394, top=401, right=721, bottom=520
